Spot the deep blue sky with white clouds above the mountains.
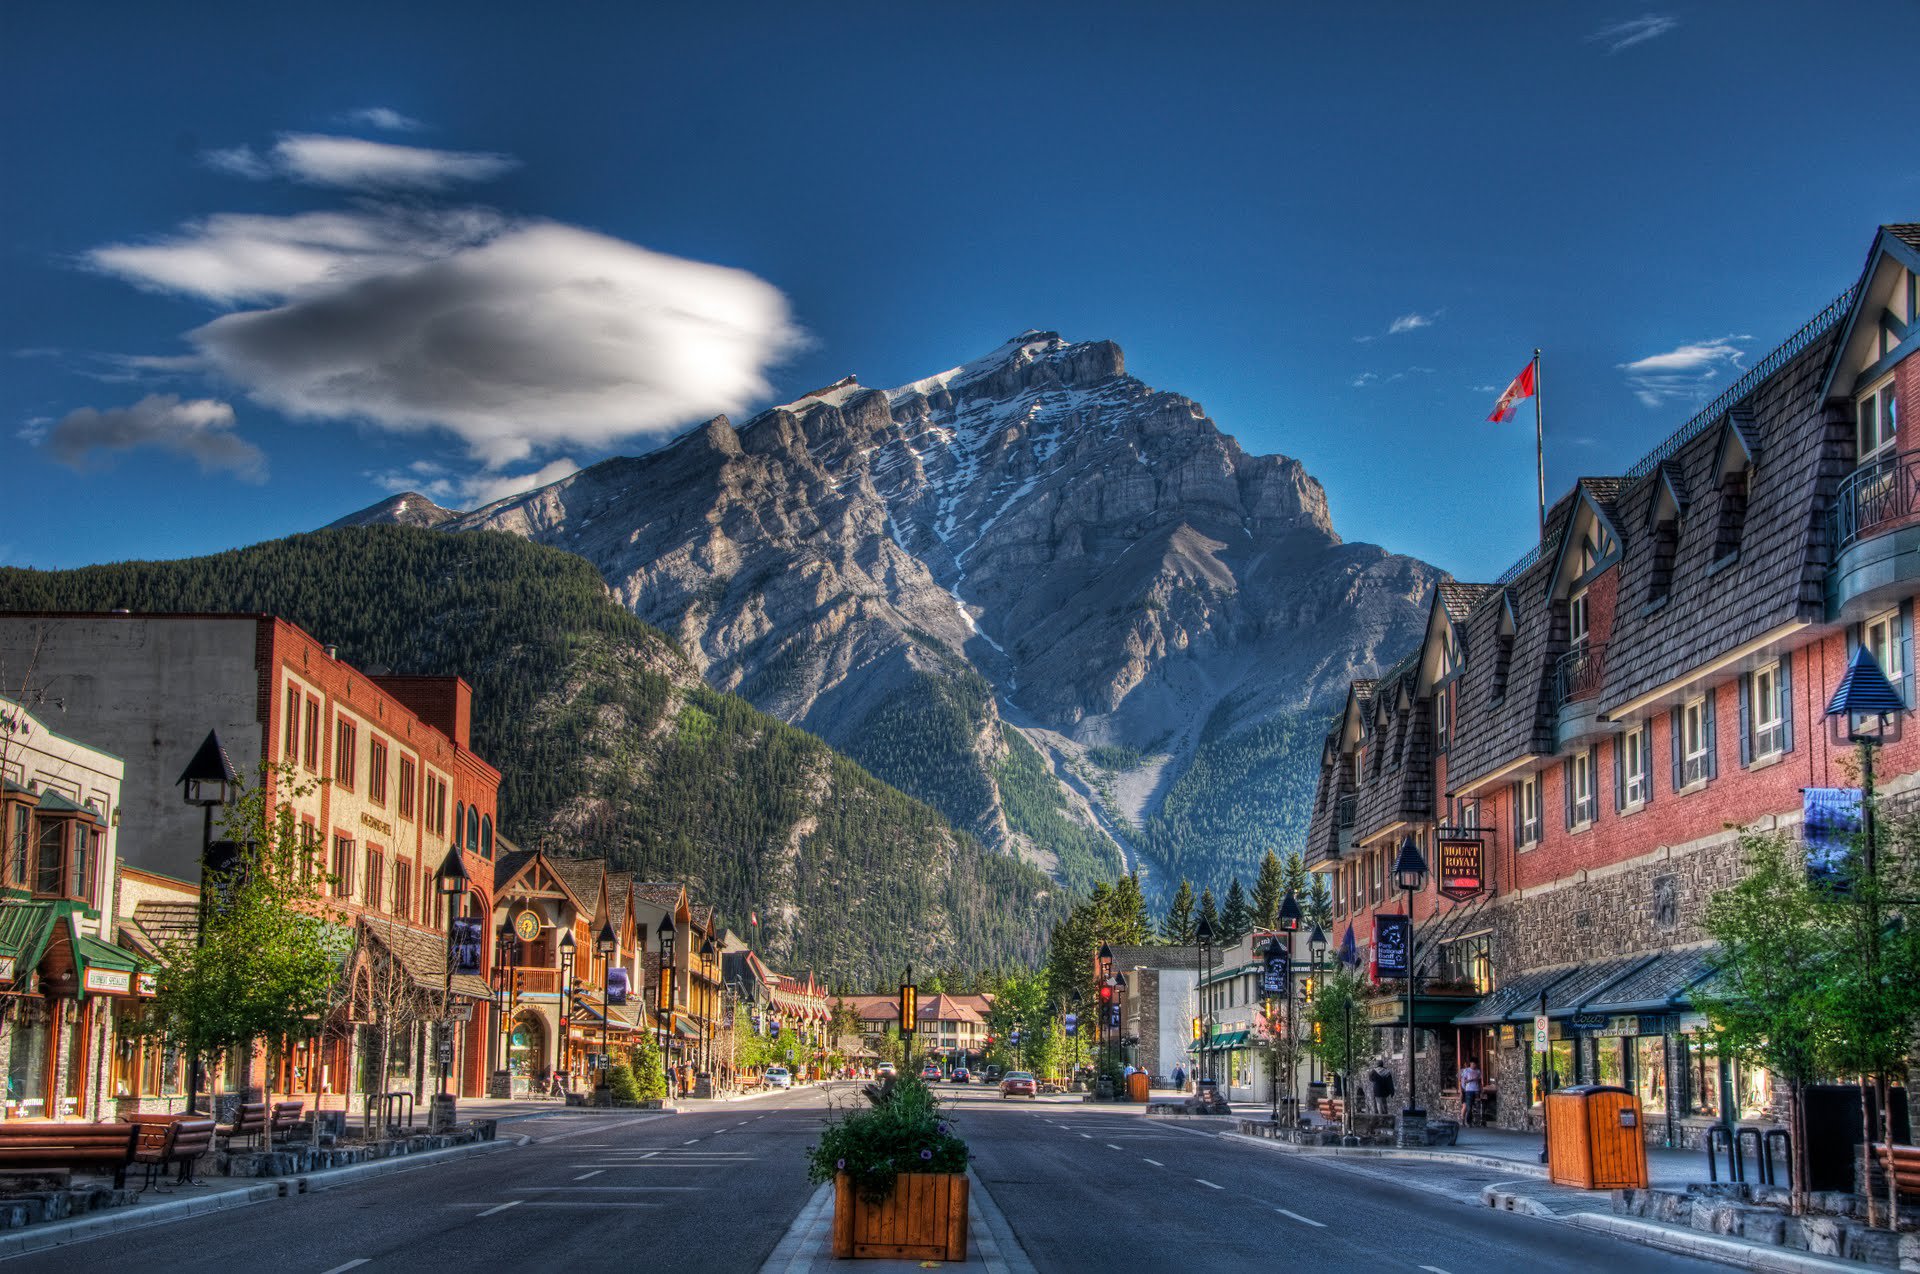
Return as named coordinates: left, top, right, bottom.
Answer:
left=0, top=0, right=1920, bottom=578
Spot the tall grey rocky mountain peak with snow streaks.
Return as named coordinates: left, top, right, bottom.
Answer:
left=420, top=332, right=1440, bottom=890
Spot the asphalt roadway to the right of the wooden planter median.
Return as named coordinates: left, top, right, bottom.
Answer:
left=943, top=1090, right=1726, bottom=1274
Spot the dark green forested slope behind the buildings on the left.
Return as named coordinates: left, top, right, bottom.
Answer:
left=0, top=526, right=1066, bottom=986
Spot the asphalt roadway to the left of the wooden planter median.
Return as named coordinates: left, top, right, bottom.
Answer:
left=6, top=1090, right=847, bottom=1274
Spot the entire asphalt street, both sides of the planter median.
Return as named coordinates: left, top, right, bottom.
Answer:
left=15, top=1084, right=1720, bottom=1274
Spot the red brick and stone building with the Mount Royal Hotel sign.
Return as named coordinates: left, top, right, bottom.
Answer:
left=1308, top=224, right=1920, bottom=1145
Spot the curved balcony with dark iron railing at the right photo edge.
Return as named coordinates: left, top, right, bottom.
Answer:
left=1826, top=451, right=1920, bottom=622
